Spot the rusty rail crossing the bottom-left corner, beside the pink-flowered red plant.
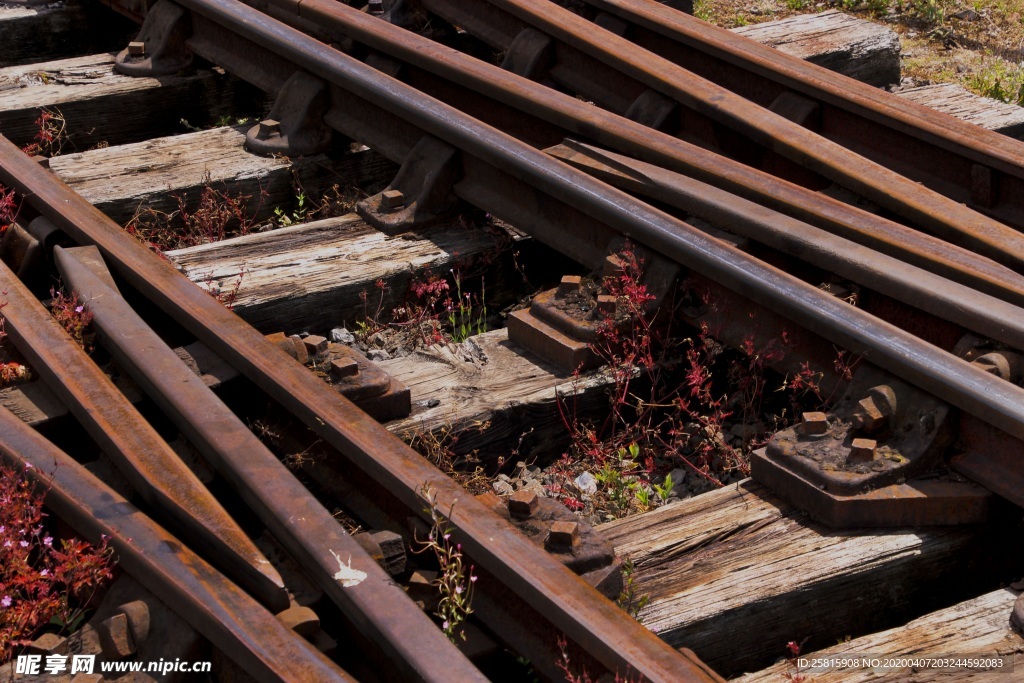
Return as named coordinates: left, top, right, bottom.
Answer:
left=0, top=409, right=354, bottom=683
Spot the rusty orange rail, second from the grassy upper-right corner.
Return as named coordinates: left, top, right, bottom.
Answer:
left=418, top=0, right=1024, bottom=271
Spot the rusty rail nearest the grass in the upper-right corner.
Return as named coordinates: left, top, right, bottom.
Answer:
left=569, top=0, right=1024, bottom=228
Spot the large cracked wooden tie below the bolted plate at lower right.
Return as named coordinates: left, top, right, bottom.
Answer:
left=600, top=479, right=1020, bottom=676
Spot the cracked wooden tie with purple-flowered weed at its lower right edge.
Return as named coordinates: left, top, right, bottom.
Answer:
left=167, top=214, right=507, bottom=333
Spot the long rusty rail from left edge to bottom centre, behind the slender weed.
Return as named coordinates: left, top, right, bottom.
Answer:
left=0, top=147, right=721, bottom=682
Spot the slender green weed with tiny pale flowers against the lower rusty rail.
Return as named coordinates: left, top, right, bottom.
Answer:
left=414, top=485, right=477, bottom=642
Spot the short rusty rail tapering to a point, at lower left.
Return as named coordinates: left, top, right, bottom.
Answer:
left=0, top=258, right=288, bottom=609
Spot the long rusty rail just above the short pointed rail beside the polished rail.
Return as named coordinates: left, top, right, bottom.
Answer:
left=256, top=0, right=1024, bottom=305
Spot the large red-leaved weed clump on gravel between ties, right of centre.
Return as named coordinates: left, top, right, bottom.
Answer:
left=547, top=246, right=824, bottom=521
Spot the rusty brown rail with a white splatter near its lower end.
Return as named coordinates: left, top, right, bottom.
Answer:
left=54, top=247, right=475, bottom=681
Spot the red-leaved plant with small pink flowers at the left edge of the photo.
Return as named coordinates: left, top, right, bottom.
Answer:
left=0, top=467, right=113, bottom=661
